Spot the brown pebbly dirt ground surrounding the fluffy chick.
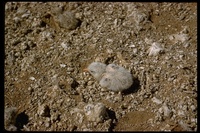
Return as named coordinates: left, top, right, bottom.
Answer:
left=4, top=2, right=197, bottom=131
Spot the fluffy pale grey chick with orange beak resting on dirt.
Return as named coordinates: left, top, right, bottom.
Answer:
left=84, top=62, right=133, bottom=92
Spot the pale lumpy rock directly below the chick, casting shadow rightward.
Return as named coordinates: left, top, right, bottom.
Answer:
left=84, top=103, right=109, bottom=123
